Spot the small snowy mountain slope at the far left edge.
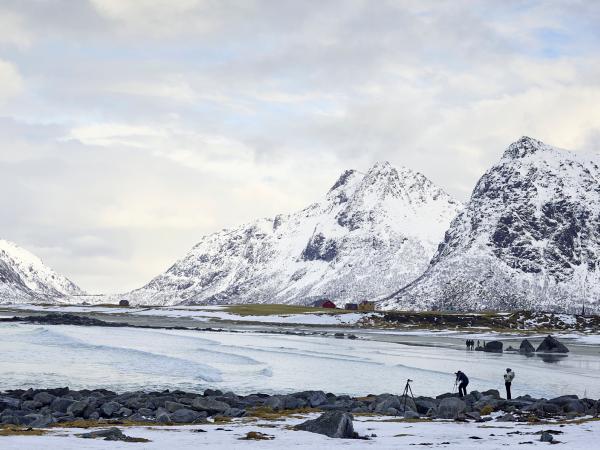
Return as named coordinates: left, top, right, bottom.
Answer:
left=0, top=240, right=84, bottom=303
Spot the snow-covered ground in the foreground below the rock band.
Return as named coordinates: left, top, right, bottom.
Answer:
left=0, top=416, right=600, bottom=450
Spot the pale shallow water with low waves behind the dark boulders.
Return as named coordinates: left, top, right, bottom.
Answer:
left=0, top=324, right=600, bottom=398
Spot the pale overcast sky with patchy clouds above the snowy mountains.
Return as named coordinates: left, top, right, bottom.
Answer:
left=0, top=0, right=600, bottom=293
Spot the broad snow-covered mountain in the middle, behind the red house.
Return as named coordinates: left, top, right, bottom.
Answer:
left=124, top=162, right=461, bottom=305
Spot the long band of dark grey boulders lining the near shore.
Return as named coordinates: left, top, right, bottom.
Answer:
left=0, top=388, right=600, bottom=428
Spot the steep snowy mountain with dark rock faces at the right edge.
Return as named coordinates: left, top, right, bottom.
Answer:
left=381, top=137, right=600, bottom=312
